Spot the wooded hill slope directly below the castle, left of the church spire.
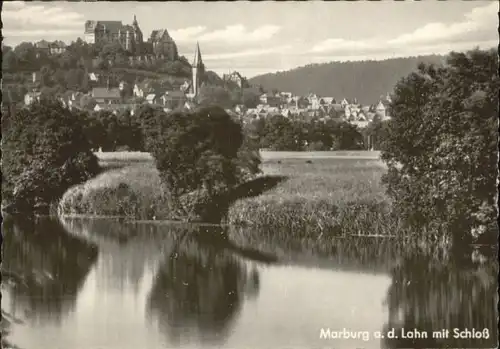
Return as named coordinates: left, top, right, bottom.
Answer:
left=2, top=38, right=191, bottom=102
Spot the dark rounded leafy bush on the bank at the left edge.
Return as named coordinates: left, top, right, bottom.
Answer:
left=2, top=100, right=99, bottom=212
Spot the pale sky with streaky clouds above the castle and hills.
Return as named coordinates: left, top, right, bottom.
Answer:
left=2, top=0, right=499, bottom=77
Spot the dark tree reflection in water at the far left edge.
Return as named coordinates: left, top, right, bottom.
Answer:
left=2, top=217, right=97, bottom=321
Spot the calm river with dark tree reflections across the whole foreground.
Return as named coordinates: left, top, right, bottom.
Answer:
left=2, top=218, right=498, bottom=349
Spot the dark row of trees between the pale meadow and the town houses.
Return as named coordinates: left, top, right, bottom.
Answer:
left=73, top=105, right=386, bottom=151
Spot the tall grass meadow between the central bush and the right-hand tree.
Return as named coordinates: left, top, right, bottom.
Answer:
left=229, top=159, right=401, bottom=239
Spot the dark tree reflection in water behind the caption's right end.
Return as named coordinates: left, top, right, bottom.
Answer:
left=385, top=246, right=498, bottom=348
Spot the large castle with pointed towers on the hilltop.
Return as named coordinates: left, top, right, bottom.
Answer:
left=84, top=16, right=178, bottom=60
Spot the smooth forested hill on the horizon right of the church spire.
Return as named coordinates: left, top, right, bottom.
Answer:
left=249, top=55, right=444, bottom=104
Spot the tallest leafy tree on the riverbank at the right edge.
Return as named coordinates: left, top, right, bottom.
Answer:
left=382, top=50, right=499, bottom=246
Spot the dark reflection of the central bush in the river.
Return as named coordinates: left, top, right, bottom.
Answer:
left=148, top=227, right=268, bottom=344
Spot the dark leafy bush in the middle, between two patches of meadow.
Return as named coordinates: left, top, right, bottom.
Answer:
left=143, top=107, right=260, bottom=219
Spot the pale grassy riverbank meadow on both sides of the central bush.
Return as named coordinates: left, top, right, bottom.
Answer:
left=59, top=152, right=410, bottom=239
